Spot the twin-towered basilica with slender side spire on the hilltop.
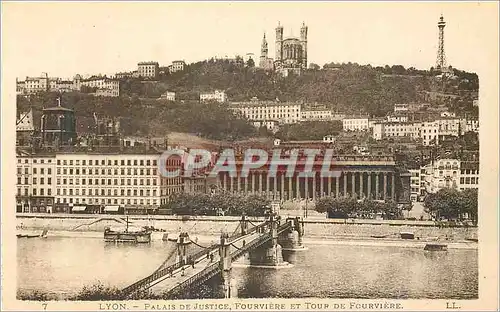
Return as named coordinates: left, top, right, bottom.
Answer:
left=260, top=23, right=307, bottom=77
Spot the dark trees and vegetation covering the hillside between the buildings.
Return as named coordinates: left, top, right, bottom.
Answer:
left=17, top=60, right=478, bottom=141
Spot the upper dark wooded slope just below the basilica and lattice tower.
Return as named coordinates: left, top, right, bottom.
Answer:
left=119, top=60, right=478, bottom=116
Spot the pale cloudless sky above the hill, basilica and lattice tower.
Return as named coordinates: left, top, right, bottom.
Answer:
left=2, top=2, right=497, bottom=78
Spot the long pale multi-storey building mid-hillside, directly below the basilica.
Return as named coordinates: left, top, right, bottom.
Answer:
left=229, top=101, right=302, bottom=124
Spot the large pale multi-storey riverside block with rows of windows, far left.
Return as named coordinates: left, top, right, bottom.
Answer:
left=18, top=148, right=187, bottom=213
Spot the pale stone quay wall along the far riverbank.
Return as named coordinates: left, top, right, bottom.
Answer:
left=16, top=214, right=477, bottom=241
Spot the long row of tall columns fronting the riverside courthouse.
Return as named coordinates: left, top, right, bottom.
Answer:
left=218, top=171, right=398, bottom=200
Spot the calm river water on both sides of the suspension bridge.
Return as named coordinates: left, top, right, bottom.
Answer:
left=17, top=237, right=478, bottom=299
